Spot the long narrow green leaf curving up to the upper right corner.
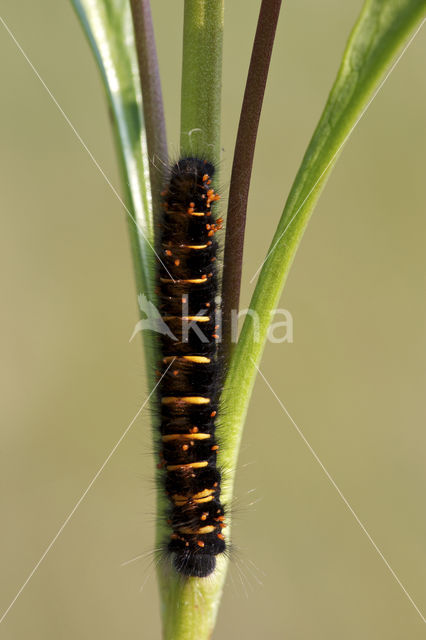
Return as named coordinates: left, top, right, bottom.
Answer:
left=219, top=0, right=426, bottom=548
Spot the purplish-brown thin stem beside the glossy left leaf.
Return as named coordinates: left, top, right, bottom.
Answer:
left=130, top=0, right=168, bottom=218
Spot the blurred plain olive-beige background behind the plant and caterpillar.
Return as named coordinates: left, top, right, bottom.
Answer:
left=0, top=0, right=426, bottom=640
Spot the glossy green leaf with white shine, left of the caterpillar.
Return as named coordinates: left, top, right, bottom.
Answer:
left=71, top=0, right=155, bottom=371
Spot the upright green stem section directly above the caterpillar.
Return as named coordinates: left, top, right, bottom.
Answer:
left=181, top=0, right=224, bottom=163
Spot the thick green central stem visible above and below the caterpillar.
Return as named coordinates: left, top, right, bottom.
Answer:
left=158, top=0, right=227, bottom=640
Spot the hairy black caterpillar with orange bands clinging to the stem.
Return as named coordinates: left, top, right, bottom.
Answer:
left=158, top=158, right=225, bottom=577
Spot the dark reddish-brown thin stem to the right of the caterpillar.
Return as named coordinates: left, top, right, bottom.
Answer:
left=222, top=0, right=282, bottom=361
